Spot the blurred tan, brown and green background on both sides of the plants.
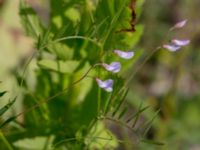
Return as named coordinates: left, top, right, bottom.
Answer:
left=0, top=0, right=200, bottom=150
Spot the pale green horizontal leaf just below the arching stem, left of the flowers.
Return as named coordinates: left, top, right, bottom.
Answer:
left=38, top=59, right=80, bottom=73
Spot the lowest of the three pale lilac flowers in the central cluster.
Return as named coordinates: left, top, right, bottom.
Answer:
left=96, top=78, right=114, bottom=92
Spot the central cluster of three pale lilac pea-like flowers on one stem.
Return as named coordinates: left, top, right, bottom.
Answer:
left=96, top=50, right=134, bottom=92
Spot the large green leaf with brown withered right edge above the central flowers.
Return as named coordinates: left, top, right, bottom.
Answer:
left=96, top=0, right=143, bottom=49
